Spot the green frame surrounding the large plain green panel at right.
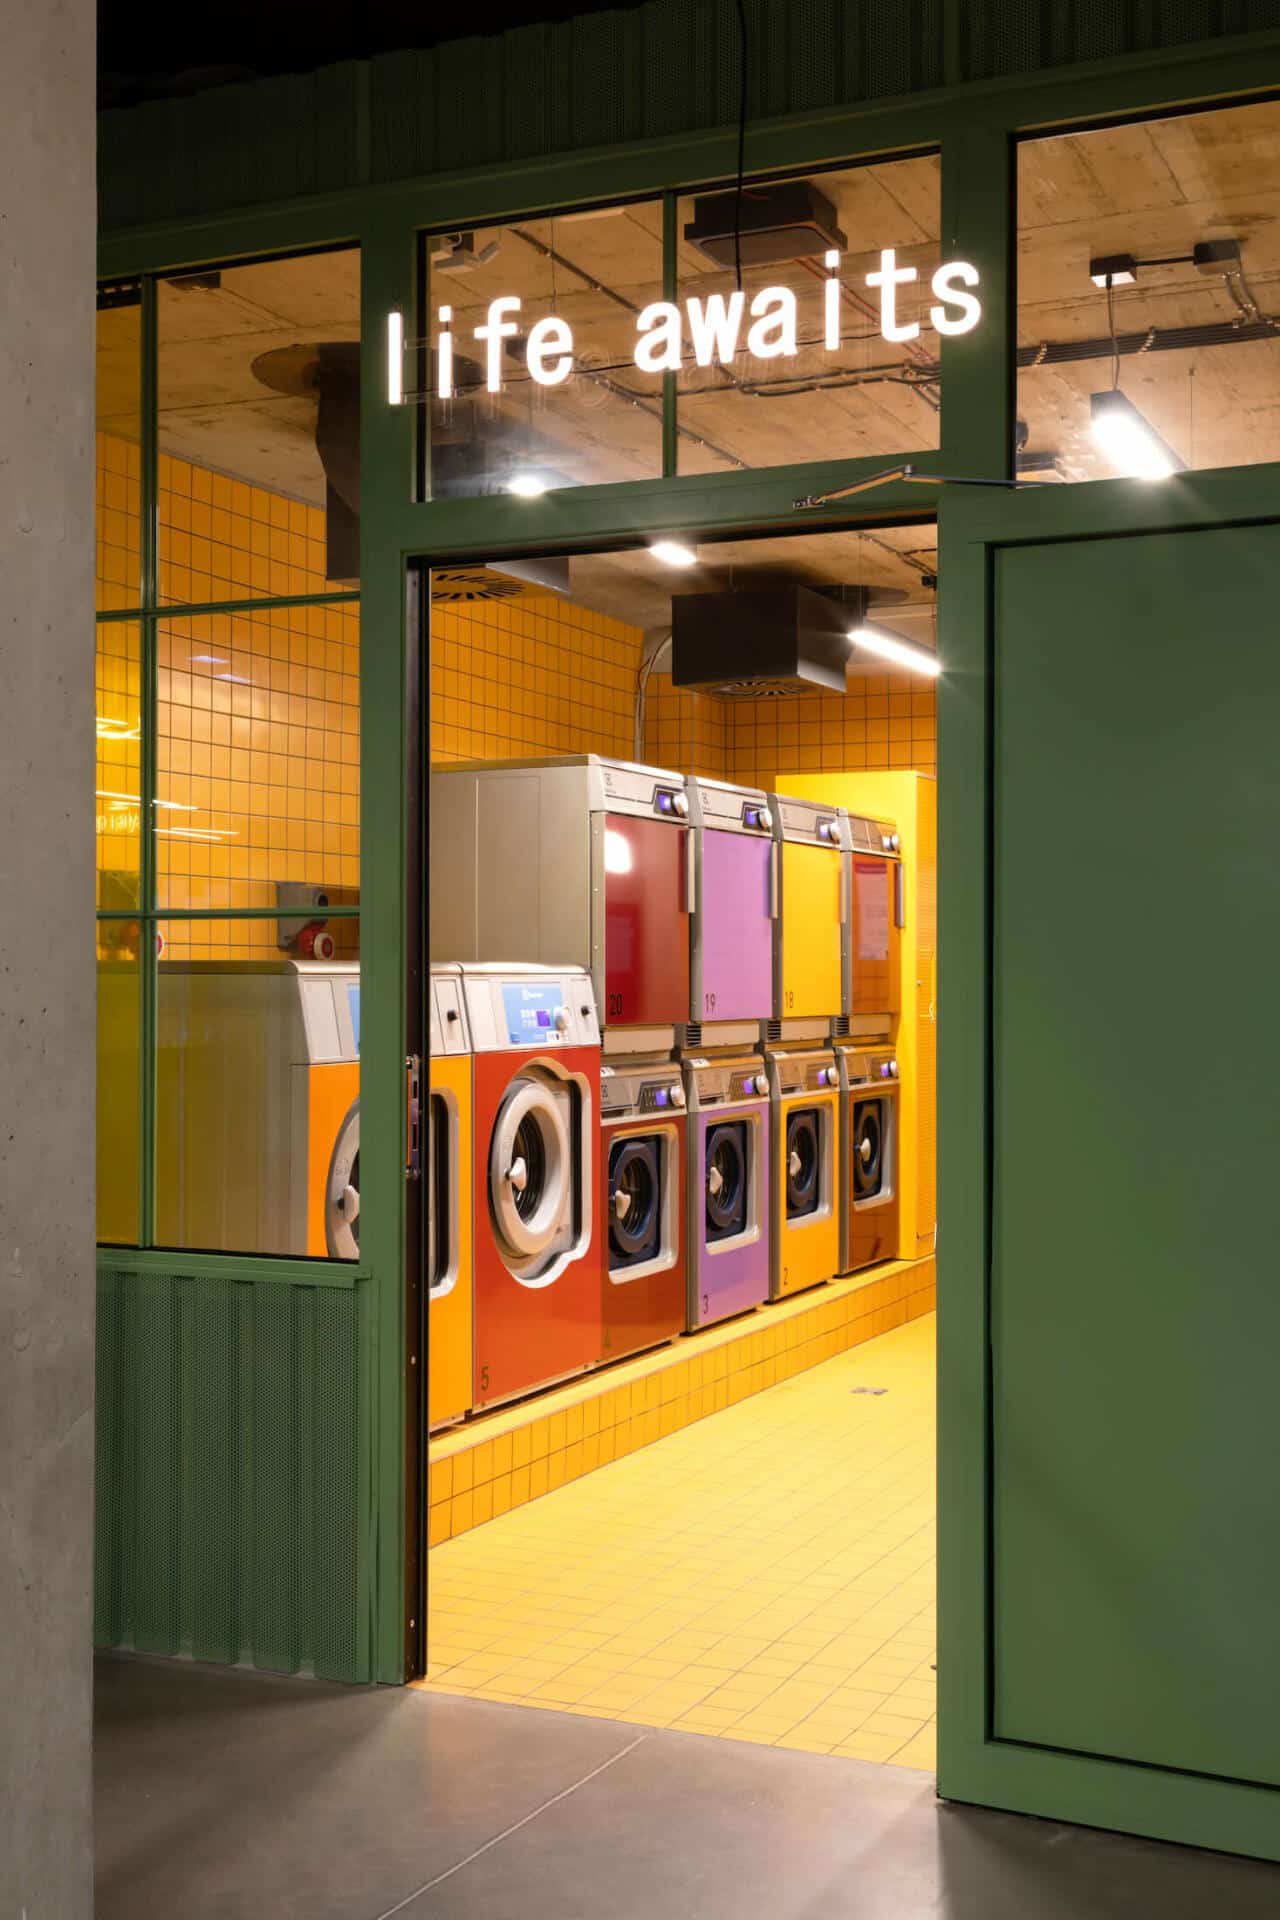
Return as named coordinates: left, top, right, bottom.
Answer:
left=938, top=465, right=1280, bottom=1859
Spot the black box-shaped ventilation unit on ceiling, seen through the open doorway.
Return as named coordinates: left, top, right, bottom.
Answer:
left=672, top=586, right=867, bottom=699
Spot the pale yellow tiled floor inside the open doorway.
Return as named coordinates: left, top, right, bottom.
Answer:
left=418, top=1315, right=935, bottom=1768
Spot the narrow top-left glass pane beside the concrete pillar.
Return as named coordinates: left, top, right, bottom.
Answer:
left=96, top=286, right=142, bottom=612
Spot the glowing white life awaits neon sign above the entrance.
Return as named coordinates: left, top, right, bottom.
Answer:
left=388, top=248, right=983, bottom=407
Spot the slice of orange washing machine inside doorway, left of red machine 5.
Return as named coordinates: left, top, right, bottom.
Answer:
left=426, top=968, right=474, bottom=1428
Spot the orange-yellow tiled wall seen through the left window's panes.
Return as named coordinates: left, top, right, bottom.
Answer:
left=98, top=436, right=359, bottom=958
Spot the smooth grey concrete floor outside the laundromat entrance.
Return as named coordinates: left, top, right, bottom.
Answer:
left=96, top=1659, right=1280, bottom=1920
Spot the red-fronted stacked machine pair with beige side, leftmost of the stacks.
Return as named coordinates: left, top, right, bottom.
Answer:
left=430, top=755, right=697, bottom=1359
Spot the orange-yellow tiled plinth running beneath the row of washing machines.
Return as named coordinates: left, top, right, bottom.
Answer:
left=428, top=1258, right=935, bottom=1546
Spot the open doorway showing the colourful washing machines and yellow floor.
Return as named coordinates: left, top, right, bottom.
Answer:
left=424, top=522, right=936, bottom=1766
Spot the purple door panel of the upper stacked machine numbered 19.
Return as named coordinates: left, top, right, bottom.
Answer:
left=689, top=829, right=773, bottom=1020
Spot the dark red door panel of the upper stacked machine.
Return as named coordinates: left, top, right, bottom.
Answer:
left=601, top=814, right=689, bottom=1027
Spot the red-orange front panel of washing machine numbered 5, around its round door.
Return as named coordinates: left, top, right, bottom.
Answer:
left=472, top=1046, right=603, bottom=1407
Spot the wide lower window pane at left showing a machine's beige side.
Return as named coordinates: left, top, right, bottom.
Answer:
left=155, top=914, right=361, bottom=1260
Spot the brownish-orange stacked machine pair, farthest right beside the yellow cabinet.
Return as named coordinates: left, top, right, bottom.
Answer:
left=837, top=814, right=904, bottom=1273
